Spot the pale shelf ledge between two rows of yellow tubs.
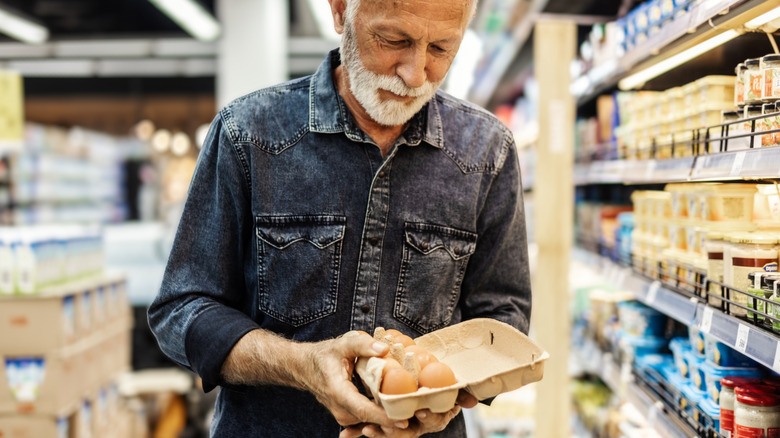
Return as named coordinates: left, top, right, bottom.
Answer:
left=574, top=146, right=780, bottom=185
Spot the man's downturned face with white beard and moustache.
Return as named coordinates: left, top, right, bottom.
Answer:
left=341, top=0, right=473, bottom=126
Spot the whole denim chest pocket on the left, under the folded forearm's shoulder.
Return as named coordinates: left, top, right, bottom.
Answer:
left=256, top=215, right=346, bottom=327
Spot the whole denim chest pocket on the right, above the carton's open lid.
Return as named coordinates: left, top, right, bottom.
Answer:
left=393, top=223, right=477, bottom=333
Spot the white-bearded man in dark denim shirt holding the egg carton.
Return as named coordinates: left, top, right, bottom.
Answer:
left=149, top=0, right=531, bottom=438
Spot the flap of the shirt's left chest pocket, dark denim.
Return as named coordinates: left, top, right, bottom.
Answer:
left=256, top=215, right=347, bottom=249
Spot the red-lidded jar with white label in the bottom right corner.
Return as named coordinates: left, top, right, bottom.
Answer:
left=731, top=385, right=780, bottom=438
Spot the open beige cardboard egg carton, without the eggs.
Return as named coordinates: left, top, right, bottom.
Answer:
left=355, top=318, right=549, bottom=420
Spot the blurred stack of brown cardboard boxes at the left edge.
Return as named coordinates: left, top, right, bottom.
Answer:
left=0, top=275, right=132, bottom=438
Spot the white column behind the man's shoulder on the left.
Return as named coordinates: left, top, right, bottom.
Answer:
left=216, top=0, right=290, bottom=108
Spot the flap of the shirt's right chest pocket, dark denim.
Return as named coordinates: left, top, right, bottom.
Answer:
left=405, top=222, right=477, bottom=260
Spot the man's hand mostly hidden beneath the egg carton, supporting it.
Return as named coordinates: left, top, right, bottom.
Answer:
left=339, top=390, right=477, bottom=438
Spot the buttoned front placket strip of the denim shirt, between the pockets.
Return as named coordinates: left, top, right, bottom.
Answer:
left=350, top=159, right=395, bottom=332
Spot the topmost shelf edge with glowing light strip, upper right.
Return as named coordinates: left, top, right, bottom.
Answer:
left=571, top=0, right=776, bottom=101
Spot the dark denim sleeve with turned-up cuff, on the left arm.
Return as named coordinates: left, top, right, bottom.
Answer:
left=148, top=116, right=258, bottom=390
